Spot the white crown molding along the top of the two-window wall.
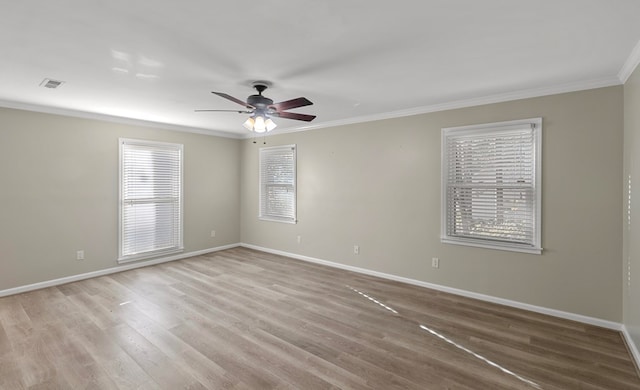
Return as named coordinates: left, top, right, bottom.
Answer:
left=252, top=77, right=622, bottom=138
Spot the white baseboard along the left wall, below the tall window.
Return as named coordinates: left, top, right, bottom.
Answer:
left=0, top=244, right=240, bottom=297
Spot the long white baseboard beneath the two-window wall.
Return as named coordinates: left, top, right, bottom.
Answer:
left=240, top=243, right=620, bottom=330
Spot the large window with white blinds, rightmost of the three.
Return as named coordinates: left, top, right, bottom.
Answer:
left=441, top=118, right=542, bottom=254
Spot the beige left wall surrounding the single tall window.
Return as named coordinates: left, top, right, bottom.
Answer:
left=0, top=109, right=240, bottom=291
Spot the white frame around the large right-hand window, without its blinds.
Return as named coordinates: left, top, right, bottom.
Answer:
left=440, top=118, right=542, bottom=254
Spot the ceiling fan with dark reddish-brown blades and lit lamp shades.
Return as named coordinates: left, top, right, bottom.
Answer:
left=196, top=81, right=316, bottom=133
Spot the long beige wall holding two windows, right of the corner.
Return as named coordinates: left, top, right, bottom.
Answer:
left=241, top=86, right=624, bottom=322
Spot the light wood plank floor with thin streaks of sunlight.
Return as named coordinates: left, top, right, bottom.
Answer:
left=0, top=248, right=640, bottom=390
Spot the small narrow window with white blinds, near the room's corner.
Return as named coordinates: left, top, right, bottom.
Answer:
left=258, top=145, right=296, bottom=223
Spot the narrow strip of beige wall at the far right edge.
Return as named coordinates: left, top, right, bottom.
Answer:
left=622, top=67, right=640, bottom=347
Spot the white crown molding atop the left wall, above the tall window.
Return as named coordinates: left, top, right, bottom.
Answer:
left=0, top=100, right=243, bottom=139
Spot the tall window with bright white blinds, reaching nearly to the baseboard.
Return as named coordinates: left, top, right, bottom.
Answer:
left=118, top=139, right=183, bottom=262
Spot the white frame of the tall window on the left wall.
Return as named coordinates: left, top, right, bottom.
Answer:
left=118, top=138, right=184, bottom=263
